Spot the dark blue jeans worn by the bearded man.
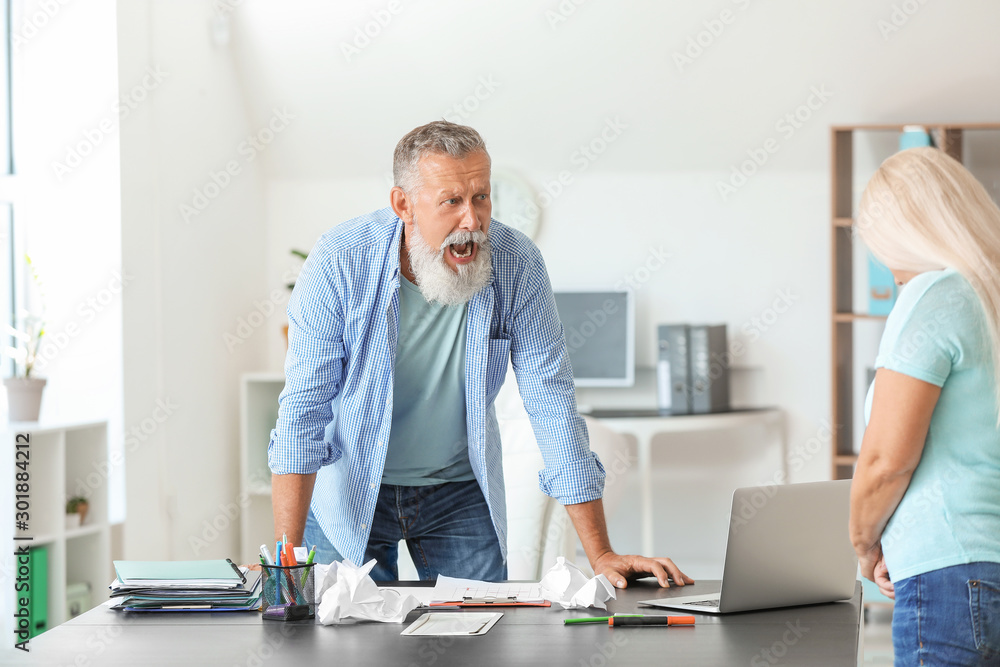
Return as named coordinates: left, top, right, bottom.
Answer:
left=303, top=480, right=507, bottom=581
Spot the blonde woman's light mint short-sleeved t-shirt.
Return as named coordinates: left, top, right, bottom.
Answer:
left=865, top=269, right=1000, bottom=581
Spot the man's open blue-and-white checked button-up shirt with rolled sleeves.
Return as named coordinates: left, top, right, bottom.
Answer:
left=267, top=208, right=604, bottom=563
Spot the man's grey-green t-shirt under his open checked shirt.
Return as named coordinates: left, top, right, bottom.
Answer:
left=382, top=275, right=476, bottom=486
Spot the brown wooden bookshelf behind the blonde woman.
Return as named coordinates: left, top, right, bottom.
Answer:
left=830, top=123, right=1000, bottom=479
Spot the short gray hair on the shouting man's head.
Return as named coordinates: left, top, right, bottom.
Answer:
left=392, top=120, right=490, bottom=195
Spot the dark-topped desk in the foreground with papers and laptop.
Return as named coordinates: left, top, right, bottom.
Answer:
left=15, top=581, right=861, bottom=667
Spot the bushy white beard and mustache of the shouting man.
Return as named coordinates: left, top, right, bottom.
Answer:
left=407, top=217, right=493, bottom=306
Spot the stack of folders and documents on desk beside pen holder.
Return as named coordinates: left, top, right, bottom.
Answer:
left=111, top=558, right=261, bottom=611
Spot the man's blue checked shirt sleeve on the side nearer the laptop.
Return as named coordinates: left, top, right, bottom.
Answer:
left=511, top=249, right=604, bottom=505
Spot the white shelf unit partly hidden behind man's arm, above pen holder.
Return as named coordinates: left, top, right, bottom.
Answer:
left=239, top=373, right=285, bottom=563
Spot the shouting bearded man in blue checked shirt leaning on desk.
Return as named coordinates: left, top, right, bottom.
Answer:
left=268, top=121, right=692, bottom=587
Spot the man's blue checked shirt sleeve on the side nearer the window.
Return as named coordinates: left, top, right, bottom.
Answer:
left=267, top=240, right=344, bottom=475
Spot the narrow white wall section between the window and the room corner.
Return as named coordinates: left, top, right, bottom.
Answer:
left=118, top=0, right=265, bottom=559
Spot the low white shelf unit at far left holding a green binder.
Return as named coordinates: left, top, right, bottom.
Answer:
left=5, top=421, right=114, bottom=628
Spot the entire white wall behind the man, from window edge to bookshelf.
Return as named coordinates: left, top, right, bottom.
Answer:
left=119, top=0, right=1000, bottom=576
